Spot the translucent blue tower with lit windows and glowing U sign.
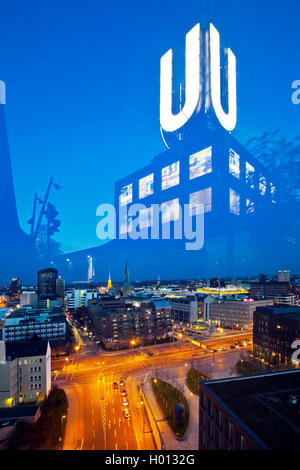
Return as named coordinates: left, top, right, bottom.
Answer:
left=55, top=24, right=294, bottom=279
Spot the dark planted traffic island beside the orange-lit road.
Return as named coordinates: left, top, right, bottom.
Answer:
left=151, top=378, right=189, bottom=439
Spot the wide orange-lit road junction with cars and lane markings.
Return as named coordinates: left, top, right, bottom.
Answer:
left=52, top=333, right=249, bottom=450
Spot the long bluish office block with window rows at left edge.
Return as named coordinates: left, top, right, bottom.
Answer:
left=2, top=307, right=67, bottom=342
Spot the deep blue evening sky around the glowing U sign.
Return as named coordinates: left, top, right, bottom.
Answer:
left=0, top=0, right=300, bottom=251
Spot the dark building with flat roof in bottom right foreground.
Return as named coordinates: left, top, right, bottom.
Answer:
left=199, top=370, right=300, bottom=450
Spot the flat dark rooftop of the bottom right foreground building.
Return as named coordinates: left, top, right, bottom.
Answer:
left=203, top=370, right=300, bottom=450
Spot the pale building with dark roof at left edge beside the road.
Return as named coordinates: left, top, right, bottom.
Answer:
left=0, top=341, right=51, bottom=407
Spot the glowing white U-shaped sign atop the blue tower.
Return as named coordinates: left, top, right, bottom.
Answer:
left=160, top=23, right=237, bottom=132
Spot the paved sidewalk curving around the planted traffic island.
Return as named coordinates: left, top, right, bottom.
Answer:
left=143, top=377, right=199, bottom=450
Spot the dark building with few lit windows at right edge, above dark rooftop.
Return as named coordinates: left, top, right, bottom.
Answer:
left=253, top=305, right=300, bottom=367
